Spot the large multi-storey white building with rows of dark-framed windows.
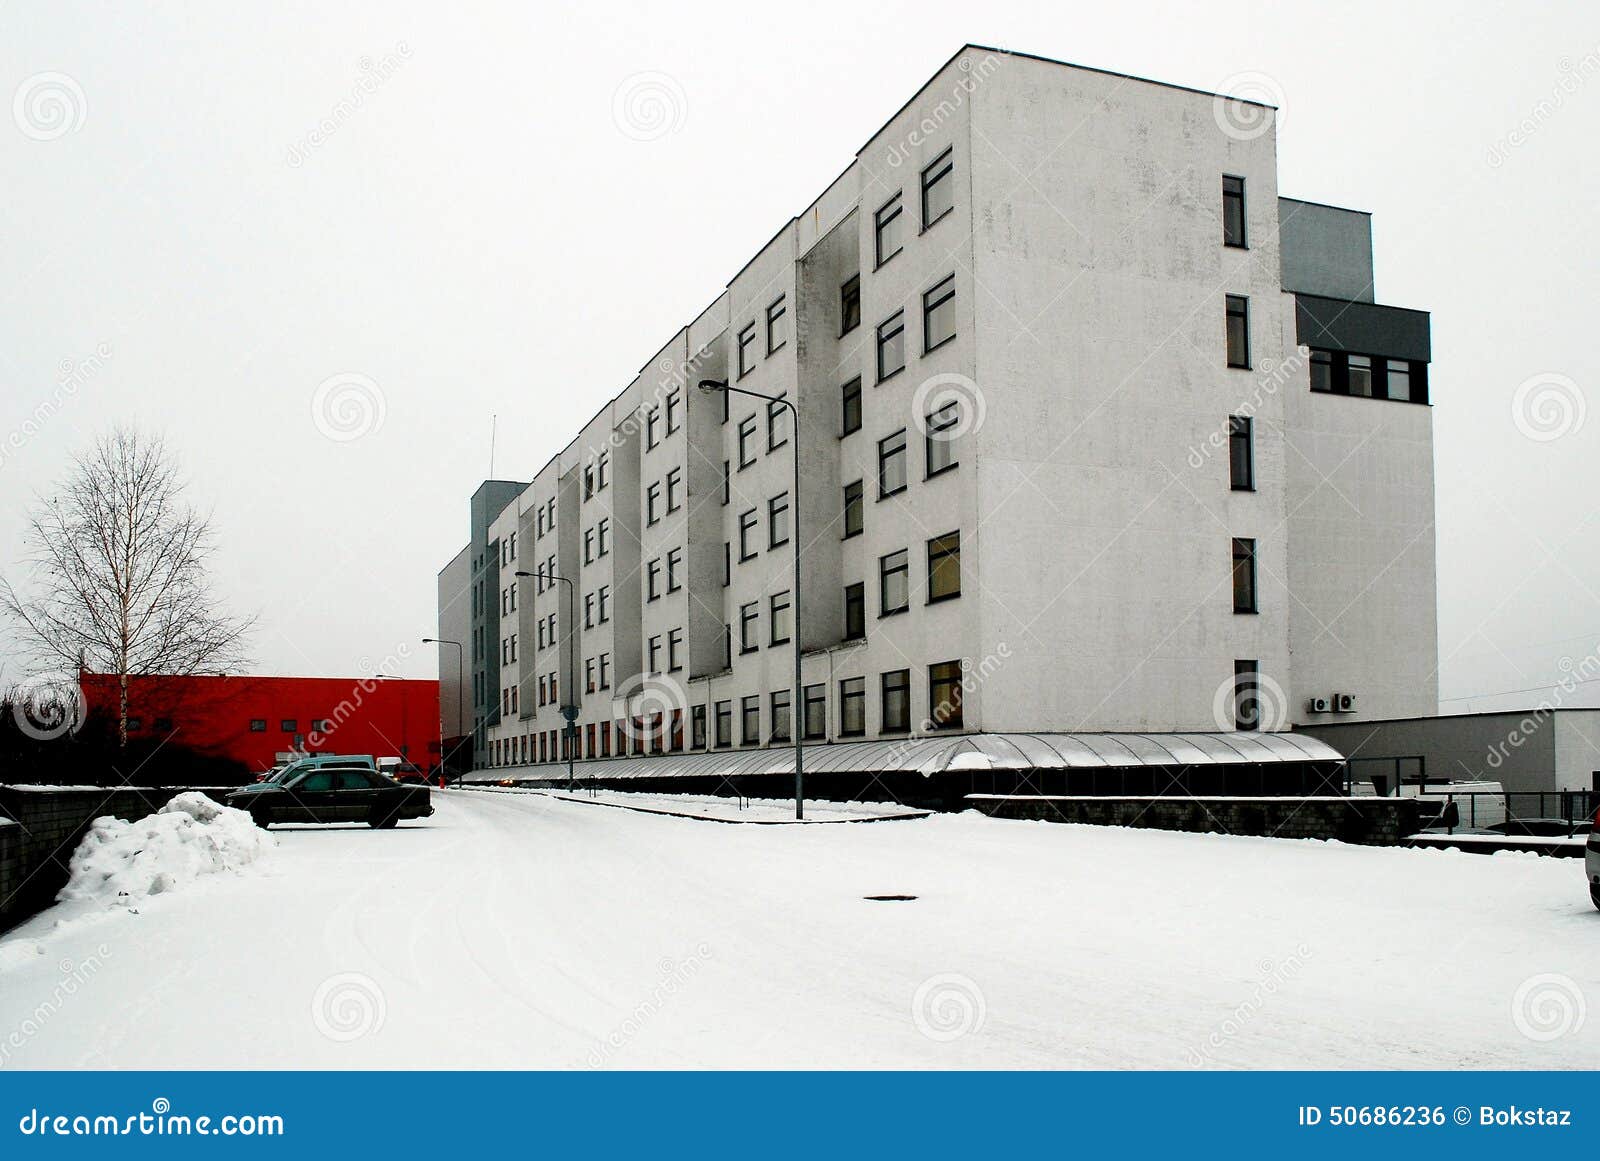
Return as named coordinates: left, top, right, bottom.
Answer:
left=440, top=46, right=1437, bottom=789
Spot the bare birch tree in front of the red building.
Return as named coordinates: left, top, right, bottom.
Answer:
left=0, top=427, right=254, bottom=745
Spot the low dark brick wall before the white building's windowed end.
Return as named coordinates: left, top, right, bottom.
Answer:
left=966, top=795, right=1421, bottom=846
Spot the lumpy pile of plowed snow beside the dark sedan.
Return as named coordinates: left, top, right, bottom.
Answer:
left=58, top=790, right=277, bottom=905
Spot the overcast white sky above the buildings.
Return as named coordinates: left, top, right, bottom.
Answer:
left=0, top=0, right=1600, bottom=710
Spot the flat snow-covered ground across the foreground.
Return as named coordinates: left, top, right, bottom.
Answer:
left=0, top=792, right=1600, bottom=1068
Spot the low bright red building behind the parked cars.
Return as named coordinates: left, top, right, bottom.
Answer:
left=80, top=673, right=440, bottom=771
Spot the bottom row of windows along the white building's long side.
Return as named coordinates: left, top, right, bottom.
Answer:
left=490, top=660, right=965, bottom=766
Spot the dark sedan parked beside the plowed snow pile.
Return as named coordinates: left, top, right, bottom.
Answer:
left=227, top=756, right=434, bottom=828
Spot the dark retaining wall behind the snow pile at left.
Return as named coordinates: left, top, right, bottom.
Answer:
left=0, top=787, right=208, bottom=931
